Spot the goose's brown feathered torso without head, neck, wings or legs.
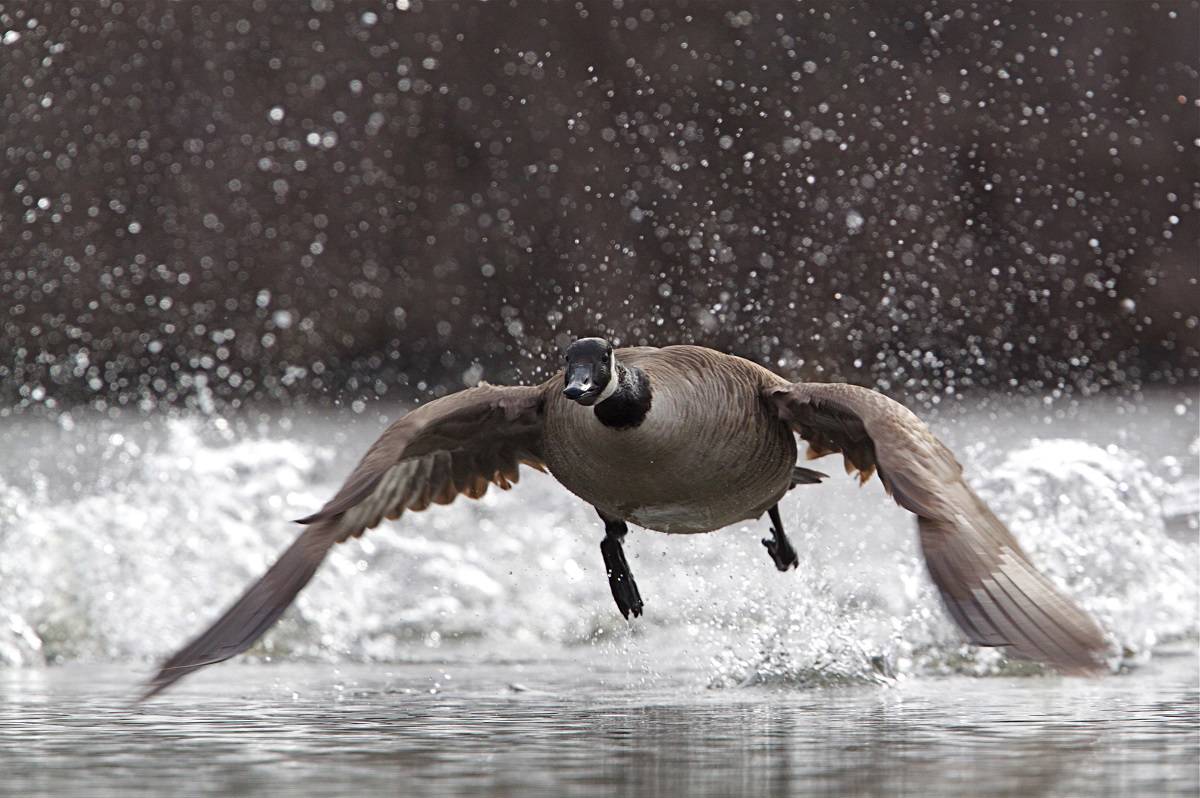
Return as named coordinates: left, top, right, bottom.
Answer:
left=545, top=346, right=796, bottom=533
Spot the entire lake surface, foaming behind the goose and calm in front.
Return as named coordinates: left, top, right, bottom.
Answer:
left=0, top=392, right=1200, bottom=796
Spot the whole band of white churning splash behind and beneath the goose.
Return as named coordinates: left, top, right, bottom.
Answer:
left=0, top=412, right=1198, bottom=686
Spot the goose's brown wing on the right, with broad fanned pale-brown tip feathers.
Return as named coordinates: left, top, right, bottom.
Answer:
left=764, top=383, right=1105, bottom=672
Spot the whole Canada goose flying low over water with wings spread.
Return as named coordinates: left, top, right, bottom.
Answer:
left=143, top=338, right=1105, bottom=697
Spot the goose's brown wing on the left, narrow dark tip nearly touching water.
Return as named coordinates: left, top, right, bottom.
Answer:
left=143, top=385, right=545, bottom=700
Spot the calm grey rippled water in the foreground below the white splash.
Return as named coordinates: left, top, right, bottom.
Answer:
left=0, top=652, right=1200, bottom=797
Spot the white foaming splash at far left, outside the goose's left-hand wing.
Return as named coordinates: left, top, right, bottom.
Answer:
left=0, top=420, right=319, bottom=664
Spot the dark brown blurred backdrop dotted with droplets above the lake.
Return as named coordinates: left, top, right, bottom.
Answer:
left=0, top=0, right=1200, bottom=408
